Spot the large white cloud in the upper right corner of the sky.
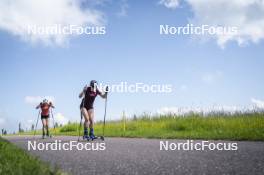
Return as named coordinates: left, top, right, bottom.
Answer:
left=160, top=0, right=264, bottom=48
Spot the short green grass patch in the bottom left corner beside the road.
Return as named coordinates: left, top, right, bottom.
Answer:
left=0, top=137, right=63, bottom=175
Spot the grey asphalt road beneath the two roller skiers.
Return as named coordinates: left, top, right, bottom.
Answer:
left=5, top=136, right=264, bottom=175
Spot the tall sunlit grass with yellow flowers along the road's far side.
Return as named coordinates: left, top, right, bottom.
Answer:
left=19, top=113, right=264, bottom=141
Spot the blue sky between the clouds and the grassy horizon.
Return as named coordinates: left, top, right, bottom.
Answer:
left=0, top=0, right=264, bottom=131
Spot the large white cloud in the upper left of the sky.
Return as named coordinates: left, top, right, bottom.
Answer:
left=0, top=0, right=104, bottom=46
